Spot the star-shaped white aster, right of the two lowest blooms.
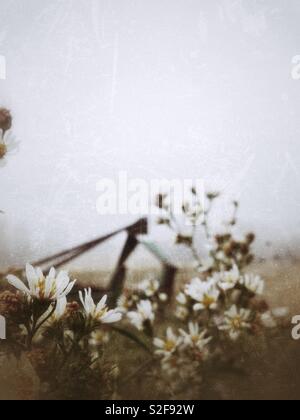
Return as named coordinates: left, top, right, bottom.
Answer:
left=219, top=305, right=251, bottom=341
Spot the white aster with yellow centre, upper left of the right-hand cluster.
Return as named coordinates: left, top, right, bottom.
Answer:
left=185, top=278, right=220, bottom=311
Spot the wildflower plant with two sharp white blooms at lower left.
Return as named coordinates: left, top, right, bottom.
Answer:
left=0, top=264, right=122, bottom=398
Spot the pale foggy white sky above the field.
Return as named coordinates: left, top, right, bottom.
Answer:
left=0, top=0, right=300, bottom=266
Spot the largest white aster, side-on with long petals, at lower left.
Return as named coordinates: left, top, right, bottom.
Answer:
left=7, top=264, right=76, bottom=302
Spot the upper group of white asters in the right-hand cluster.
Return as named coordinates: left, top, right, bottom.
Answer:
left=176, top=266, right=270, bottom=341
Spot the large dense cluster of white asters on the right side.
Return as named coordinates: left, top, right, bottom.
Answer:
left=150, top=265, right=286, bottom=387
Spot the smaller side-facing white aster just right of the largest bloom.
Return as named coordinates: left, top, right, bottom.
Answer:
left=79, top=289, right=122, bottom=324
